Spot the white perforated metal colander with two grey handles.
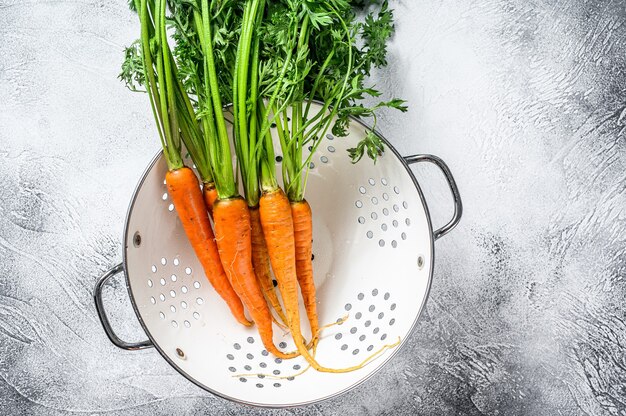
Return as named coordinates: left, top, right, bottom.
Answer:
left=94, top=104, right=462, bottom=407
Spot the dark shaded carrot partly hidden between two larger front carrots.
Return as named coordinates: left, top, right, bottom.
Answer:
left=250, top=207, right=287, bottom=326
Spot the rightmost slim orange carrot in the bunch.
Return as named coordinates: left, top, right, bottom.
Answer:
left=291, top=199, right=319, bottom=342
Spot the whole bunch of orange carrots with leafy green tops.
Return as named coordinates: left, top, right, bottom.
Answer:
left=120, top=0, right=405, bottom=372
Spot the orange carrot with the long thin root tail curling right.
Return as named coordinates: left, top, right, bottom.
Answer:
left=258, top=188, right=399, bottom=373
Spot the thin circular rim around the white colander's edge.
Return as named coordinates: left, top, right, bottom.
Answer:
left=122, top=115, right=435, bottom=409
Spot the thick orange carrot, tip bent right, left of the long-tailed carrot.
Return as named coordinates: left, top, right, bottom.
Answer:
left=213, top=197, right=297, bottom=359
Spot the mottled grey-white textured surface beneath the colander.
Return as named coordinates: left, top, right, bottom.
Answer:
left=0, top=0, right=626, bottom=416
